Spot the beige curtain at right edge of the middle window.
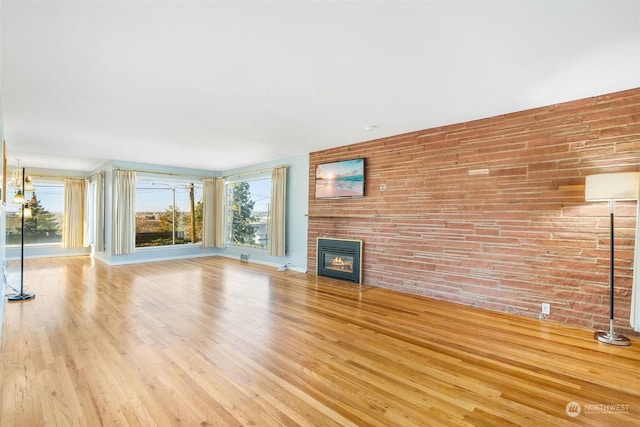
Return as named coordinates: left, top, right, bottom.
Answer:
left=202, top=178, right=225, bottom=248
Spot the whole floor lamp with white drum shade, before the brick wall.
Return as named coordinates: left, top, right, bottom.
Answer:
left=585, top=172, right=640, bottom=345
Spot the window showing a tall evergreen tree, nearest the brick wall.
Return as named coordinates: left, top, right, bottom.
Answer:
left=226, top=173, right=271, bottom=249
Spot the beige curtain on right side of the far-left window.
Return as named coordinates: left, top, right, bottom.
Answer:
left=62, top=178, right=87, bottom=248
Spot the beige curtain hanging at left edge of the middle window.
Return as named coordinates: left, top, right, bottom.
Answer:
left=113, top=170, right=136, bottom=255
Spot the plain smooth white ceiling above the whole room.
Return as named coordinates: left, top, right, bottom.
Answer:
left=0, top=0, right=640, bottom=171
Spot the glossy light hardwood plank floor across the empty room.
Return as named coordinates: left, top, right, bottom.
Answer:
left=0, top=257, right=640, bottom=427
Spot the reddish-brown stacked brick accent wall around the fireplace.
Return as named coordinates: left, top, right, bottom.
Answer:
left=308, top=88, right=640, bottom=337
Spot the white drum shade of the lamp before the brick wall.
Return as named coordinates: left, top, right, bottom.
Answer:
left=584, top=172, right=640, bottom=202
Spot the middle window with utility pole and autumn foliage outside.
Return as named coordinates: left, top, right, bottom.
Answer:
left=136, top=176, right=202, bottom=247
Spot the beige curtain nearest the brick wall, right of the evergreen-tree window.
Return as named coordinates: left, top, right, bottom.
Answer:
left=269, top=166, right=287, bottom=256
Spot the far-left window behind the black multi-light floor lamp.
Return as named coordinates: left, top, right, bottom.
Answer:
left=7, top=178, right=64, bottom=245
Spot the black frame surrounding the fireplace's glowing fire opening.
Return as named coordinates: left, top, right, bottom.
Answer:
left=316, top=237, right=362, bottom=284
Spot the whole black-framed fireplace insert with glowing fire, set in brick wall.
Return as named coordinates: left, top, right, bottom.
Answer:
left=317, top=237, right=362, bottom=283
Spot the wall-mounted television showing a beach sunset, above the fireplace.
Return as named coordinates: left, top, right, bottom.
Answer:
left=316, top=158, right=364, bottom=199
